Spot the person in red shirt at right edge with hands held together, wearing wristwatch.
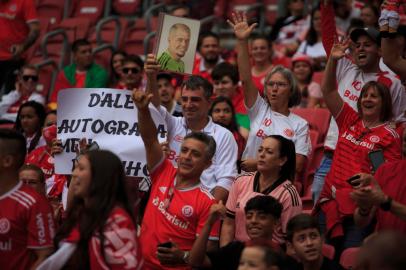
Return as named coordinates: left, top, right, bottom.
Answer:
left=351, top=128, right=406, bottom=233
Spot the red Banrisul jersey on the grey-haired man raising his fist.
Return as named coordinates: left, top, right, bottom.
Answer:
left=140, top=159, right=219, bottom=269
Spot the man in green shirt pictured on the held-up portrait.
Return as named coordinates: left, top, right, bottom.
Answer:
left=158, top=23, right=190, bottom=73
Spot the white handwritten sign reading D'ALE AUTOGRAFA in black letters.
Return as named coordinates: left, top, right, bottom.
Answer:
left=55, top=88, right=167, bottom=177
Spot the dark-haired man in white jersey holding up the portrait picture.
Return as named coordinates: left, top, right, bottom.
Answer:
left=145, top=54, right=238, bottom=202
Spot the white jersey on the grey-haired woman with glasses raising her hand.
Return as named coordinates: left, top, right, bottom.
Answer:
left=242, top=94, right=311, bottom=159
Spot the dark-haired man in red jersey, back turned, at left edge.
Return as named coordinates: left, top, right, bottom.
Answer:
left=0, top=129, right=55, bottom=270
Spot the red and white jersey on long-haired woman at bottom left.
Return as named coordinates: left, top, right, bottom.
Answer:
left=65, top=207, right=143, bottom=270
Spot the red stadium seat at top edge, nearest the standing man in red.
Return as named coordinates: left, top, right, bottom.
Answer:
left=36, top=0, right=69, bottom=29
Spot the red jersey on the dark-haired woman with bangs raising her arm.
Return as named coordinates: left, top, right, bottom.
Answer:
left=322, top=103, right=401, bottom=214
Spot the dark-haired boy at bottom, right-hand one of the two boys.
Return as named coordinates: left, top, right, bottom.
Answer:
left=286, top=214, right=342, bottom=270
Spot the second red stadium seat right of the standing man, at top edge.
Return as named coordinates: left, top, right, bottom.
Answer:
left=71, top=0, right=106, bottom=25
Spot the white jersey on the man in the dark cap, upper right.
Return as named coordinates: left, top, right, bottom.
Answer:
left=324, top=58, right=406, bottom=150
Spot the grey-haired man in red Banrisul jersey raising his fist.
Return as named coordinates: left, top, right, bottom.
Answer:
left=133, top=87, right=219, bottom=269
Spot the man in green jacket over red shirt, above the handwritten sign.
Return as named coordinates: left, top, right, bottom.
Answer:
left=48, top=39, right=108, bottom=110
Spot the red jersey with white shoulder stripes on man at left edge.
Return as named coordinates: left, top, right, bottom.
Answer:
left=0, top=182, right=55, bottom=270
